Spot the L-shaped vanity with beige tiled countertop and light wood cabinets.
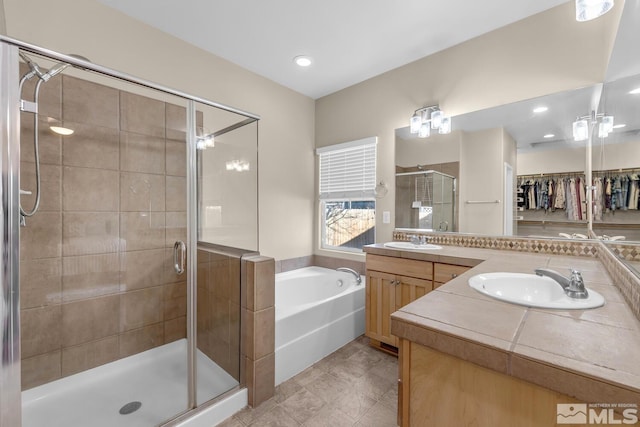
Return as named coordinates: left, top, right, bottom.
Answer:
left=365, top=245, right=640, bottom=426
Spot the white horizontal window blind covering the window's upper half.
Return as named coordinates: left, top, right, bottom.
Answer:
left=317, top=137, right=377, bottom=200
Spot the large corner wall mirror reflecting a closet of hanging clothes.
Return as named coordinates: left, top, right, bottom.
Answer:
left=395, top=0, right=640, bottom=254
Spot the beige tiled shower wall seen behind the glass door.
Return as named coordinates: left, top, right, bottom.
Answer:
left=20, top=71, right=194, bottom=389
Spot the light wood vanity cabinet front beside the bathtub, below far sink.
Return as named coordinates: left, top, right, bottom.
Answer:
left=365, top=254, right=433, bottom=354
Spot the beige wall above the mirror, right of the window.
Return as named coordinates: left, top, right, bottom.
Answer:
left=316, top=2, right=622, bottom=247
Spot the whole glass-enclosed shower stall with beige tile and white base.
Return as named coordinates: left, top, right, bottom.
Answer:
left=0, top=37, right=259, bottom=427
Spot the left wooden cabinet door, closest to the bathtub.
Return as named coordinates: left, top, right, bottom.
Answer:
left=365, top=271, right=398, bottom=347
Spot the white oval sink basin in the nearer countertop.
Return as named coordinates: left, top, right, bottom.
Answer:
left=469, top=273, right=604, bottom=310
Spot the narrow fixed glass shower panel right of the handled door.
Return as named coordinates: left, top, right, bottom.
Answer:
left=195, top=103, right=258, bottom=404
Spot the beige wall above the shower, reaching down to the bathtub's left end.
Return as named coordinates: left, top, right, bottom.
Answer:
left=4, top=0, right=314, bottom=259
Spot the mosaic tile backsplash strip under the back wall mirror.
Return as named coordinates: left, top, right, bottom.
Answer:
left=393, top=231, right=601, bottom=257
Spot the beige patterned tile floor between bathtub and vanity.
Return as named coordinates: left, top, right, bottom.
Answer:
left=219, top=336, right=398, bottom=427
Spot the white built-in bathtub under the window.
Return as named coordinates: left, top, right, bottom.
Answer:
left=275, top=267, right=365, bottom=385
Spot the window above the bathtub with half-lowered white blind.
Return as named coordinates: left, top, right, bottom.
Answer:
left=317, top=137, right=377, bottom=252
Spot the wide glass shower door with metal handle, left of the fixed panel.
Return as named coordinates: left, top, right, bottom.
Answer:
left=20, top=47, right=190, bottom=427
